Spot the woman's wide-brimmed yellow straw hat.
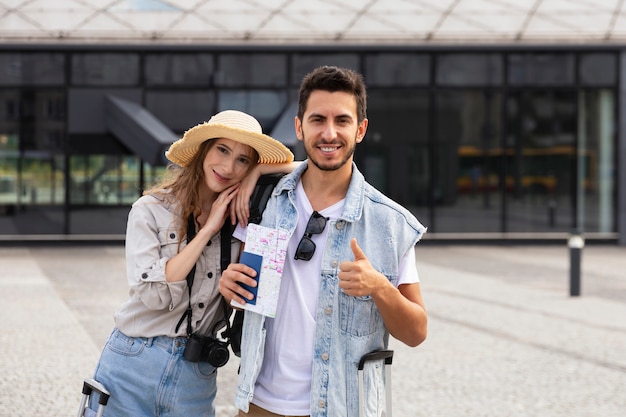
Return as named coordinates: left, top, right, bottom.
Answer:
left=165, top=110, right=293, bottom=166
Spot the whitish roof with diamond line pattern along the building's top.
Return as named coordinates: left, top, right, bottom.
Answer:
left=0, top=0, right=626, bottom=45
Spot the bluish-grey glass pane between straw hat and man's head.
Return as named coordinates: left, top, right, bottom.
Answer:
left=218, top=90, right=287, bottom=129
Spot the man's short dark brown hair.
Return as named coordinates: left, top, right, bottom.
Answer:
left=298, top=66, right=367, bottom=123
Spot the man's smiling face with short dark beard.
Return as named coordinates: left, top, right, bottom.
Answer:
left=295, top=90, right=368, bottom=171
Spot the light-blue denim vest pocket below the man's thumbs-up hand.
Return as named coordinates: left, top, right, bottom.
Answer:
left=339, top=291, right=382, bottom=336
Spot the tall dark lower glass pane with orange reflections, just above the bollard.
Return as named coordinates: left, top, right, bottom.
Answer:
left=501, top=90, right=577, bottom=232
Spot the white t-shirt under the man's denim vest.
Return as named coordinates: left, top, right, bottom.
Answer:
left=234, top=182, right=419, bottom=416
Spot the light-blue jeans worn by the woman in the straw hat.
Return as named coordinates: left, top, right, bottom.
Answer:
left=90, top=329, right=217, bottom=417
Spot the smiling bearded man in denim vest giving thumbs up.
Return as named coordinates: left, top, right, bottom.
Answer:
left=220, top=67, right=427, bottom=417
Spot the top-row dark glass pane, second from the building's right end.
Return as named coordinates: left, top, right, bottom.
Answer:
left=508, top=53, right=575, bottom=86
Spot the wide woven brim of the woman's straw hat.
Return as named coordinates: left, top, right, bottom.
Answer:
left=165, top=123, right=293, bottom=166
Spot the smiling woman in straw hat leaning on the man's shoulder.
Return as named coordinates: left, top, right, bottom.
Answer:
left=90, top=110, right=293, bottom=417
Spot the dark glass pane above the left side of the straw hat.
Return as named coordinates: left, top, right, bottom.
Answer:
left=146, top=90, right=215, bottom=132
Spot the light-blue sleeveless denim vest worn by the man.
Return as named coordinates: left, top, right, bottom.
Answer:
left=235, top=162, right=426, bottom=417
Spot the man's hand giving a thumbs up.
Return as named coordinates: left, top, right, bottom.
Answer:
left=339, top=238, right=387, bottom=297
